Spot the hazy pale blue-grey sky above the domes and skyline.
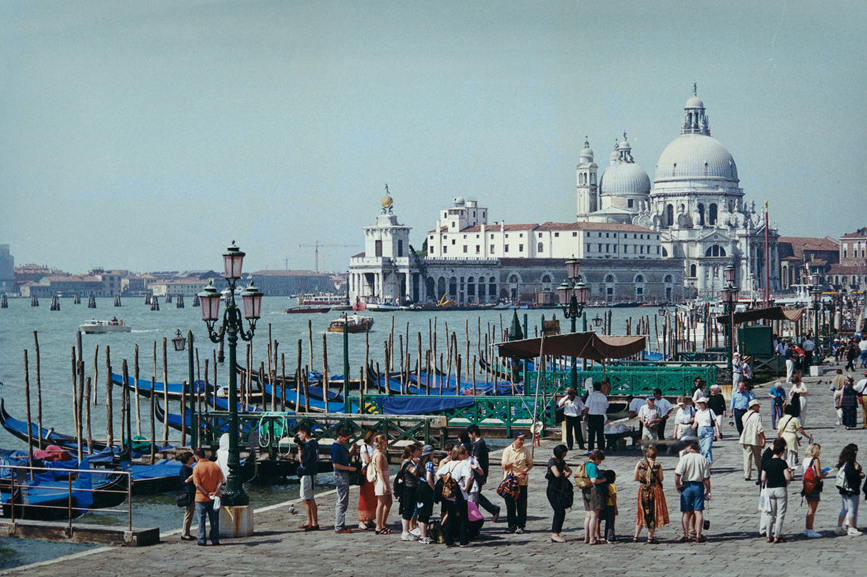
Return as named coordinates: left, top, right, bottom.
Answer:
left=0, top=0, right=867, bottom=273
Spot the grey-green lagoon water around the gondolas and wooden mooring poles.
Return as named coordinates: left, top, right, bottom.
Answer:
left=0, top=297, right=656, bottom=568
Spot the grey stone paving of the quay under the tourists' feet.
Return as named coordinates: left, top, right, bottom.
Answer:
left=2, top=364, right=867, bottom=577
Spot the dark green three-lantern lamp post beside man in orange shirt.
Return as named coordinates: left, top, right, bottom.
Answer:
left=199, top=241, right=262, bottom=507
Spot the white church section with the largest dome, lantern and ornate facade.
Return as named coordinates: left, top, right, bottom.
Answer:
left=632, top=89, right=780, bottom=298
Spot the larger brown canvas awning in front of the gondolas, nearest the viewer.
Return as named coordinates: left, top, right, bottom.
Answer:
left=497, top=332, right=645, bottom=361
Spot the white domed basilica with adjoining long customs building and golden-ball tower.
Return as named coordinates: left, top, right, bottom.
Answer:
left=349, top=90, right=780, bottom=304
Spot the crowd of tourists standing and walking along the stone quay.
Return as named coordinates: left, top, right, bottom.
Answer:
left=181, top=336, right=867, bottom=546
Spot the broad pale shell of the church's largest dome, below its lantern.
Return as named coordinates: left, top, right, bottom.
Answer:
left=654, top=134, right=738, bottom=183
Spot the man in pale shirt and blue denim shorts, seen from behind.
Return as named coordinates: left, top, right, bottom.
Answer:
left=674, top=441, right=710, bottom=543
